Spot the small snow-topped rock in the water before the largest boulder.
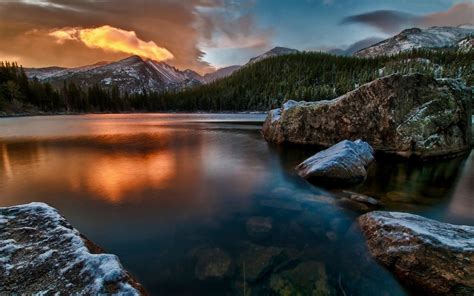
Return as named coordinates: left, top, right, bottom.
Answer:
left=296, top=140, right=374, bottom=185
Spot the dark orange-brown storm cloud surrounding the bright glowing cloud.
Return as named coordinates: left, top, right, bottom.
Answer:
left=0, top=0, right=266, bottom=71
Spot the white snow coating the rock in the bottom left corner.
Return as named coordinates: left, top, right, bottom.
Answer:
left=0, top=202, right=139, bottom=295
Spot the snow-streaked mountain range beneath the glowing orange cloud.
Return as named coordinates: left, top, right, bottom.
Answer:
left=25, top=47, right=298, bottom=93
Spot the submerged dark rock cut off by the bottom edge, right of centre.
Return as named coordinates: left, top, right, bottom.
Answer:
left=270, top=261, right=334, bottom=296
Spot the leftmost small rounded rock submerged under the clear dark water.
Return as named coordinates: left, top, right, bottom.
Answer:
left=194, top=248, right=233, bottom=280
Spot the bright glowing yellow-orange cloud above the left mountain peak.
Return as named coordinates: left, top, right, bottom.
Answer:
left=49, top=26, right=173, bottom=61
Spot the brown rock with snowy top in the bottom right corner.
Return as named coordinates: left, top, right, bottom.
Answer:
left=359, top=211, right=474, bottom=295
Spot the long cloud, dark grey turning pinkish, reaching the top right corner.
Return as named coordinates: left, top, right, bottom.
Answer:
left=341, top=3, right=474, bottom=34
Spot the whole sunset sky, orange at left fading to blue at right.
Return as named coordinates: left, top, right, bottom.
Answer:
left=0, top=0, right=474, bottom=73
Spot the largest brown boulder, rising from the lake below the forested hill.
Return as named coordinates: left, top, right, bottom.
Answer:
left=263, top=74, right=471, bottom=158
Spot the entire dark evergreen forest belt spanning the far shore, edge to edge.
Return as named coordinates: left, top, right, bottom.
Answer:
left=0, top=50, right=474, bottom=113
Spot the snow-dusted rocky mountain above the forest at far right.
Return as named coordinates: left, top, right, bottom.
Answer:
left=355, top=26, right=474, bottom=57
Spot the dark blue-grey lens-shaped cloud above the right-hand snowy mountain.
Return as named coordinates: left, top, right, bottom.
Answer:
left=341, top=10, right=417, bottom=34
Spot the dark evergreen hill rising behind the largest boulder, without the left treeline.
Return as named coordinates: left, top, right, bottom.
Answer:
left=155, top=49, right=474, bottom=111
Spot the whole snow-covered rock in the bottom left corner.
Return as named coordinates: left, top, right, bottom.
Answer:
left=0, top=203, right=144, bottom=295
